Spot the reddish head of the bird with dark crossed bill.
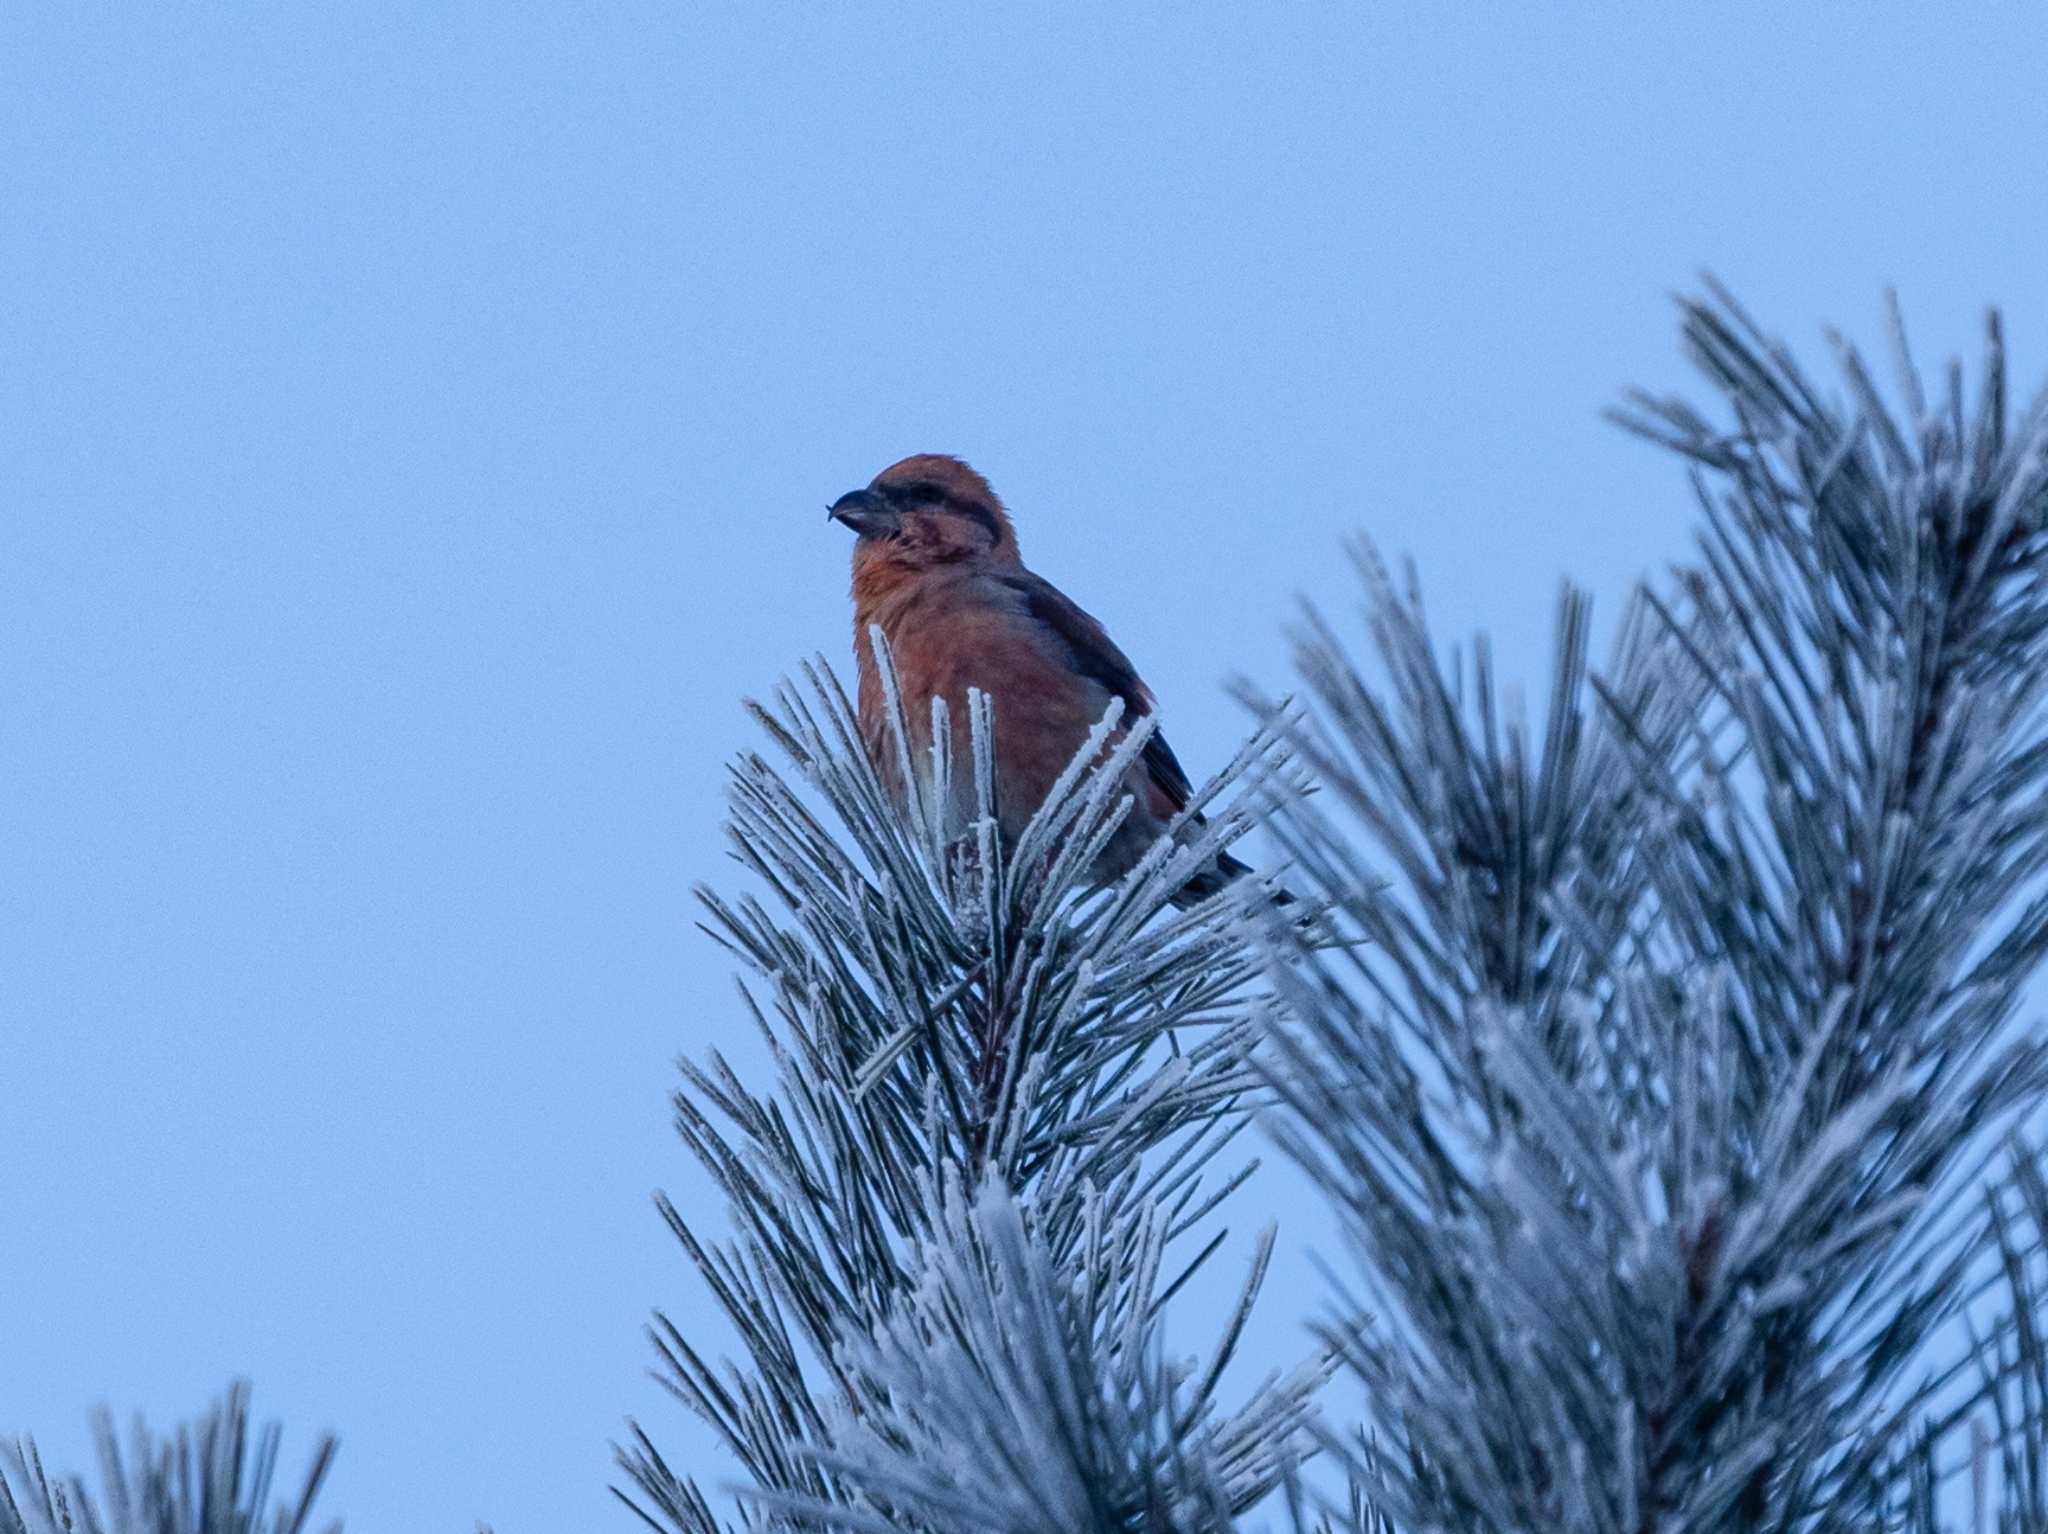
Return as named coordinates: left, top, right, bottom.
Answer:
left=829, top=453, right=1018, bottom=586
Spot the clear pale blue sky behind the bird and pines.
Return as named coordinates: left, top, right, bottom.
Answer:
left=0, top=11, right=2048, bottom=1534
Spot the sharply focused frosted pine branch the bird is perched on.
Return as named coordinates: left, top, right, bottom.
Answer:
left=621, top=649, right=1313, bottom=1530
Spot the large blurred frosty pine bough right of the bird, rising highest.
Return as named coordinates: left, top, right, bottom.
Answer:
left=1253, top=299, right=2048, bottom=1534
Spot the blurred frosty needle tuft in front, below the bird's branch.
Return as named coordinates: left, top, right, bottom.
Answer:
left=760, top=1180, right=1327, bottom=1534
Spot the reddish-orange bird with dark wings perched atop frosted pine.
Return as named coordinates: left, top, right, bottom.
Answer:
left=827, top=453, right=1286, bottom=907
